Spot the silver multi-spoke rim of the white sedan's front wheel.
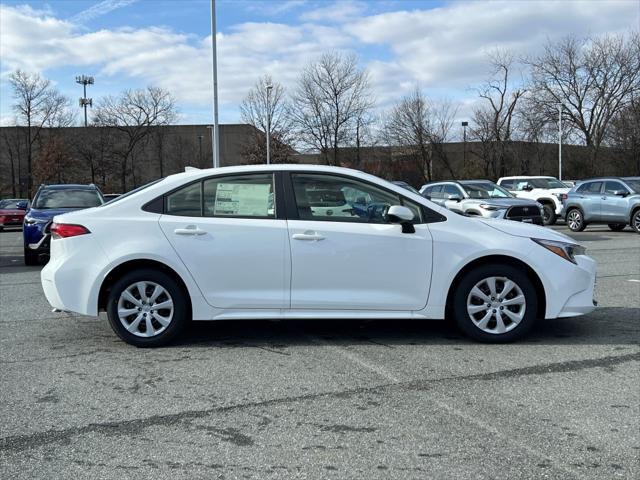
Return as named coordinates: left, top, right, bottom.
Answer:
left=467, top=277, right=527, bottom=334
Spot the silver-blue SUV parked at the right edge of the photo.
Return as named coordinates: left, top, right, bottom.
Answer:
left=563, top=177, right=640, bottom=233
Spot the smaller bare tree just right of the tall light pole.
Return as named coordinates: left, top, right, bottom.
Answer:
left=240, top=75, right=294, bottom=163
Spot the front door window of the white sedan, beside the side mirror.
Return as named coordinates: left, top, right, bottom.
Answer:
left=291, top=173, right=422, bottom=223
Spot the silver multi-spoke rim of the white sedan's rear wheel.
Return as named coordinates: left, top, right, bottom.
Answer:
left=118, top=281, right=174, bottom=337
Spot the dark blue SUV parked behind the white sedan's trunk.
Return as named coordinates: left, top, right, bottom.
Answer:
left=22, top=184, right=104, bottom=265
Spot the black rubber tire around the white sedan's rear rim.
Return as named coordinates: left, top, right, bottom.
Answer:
left=106, top=269, right=191, bottom=347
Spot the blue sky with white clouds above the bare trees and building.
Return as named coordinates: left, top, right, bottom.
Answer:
left=0, top=0, right=640, bottom=125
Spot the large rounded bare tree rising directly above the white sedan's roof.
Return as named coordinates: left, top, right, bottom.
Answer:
left=292, top=53, right=373, bottom=165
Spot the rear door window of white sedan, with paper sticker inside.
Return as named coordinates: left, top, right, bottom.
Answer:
left=203, top=173, right=276, bottom=218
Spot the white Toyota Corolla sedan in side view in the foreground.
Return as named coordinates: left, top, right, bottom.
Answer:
left=42, top=165, right=596, bottom=346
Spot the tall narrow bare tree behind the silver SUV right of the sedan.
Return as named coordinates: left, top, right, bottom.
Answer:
left=471, top=50, right=525, bottom=177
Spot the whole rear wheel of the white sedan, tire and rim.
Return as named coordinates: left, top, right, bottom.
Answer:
left=106, top=269, right=189, bottom=347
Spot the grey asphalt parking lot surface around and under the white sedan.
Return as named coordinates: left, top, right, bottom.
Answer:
left=0, top=226, right=640, bottom=479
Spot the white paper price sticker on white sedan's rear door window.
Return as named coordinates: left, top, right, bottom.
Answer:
left=213, top=183, right=273, bottom=217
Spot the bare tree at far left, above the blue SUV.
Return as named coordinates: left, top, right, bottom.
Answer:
left=9, top=70, right=69, bottom=196
